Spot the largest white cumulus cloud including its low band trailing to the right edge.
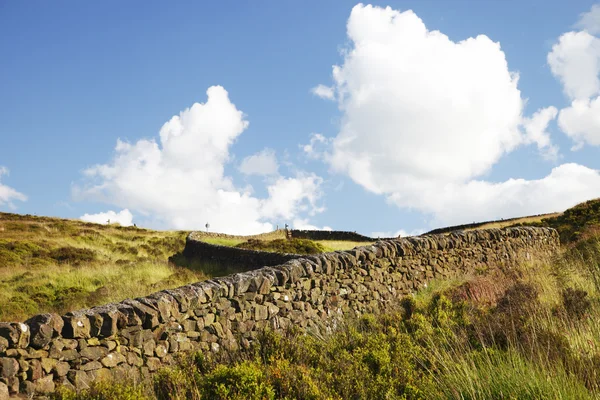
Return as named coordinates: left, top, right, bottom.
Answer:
left=305, top=4, right=600, bottom=224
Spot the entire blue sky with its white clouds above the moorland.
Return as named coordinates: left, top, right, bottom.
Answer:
left=0, top=0, right=600, bottom=235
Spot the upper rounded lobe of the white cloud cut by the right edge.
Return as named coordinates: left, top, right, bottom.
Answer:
left=547, top=32, right=600, bottom=100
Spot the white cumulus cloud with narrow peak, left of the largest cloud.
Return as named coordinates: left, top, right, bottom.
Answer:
left=74, top=86, right=321, bottom=234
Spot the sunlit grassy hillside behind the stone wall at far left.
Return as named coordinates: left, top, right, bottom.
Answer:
left=0, top=213, right=205, bottom=321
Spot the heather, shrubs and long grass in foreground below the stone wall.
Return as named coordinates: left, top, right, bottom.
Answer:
left=55, top=203, right=600, bottom=400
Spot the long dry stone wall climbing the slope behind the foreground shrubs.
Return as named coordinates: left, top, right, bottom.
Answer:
left=0, top=228, right=559, bottom=399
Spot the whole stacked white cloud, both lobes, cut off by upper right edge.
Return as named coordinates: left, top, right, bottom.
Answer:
left=548, top=12, right=600, bottom=150
